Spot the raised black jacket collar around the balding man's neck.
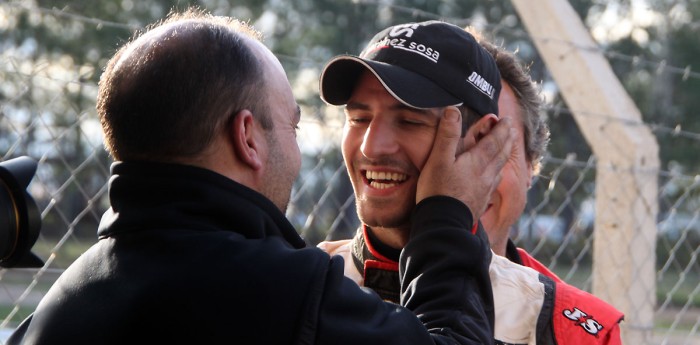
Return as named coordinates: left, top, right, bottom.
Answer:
left=98, top=161, right=306, bottom=248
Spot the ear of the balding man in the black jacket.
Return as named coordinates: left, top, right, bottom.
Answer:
left=229, top=109, right=263, bottom=170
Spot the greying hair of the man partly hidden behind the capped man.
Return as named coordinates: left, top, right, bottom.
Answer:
left=466, top=28, right=549, bottom=175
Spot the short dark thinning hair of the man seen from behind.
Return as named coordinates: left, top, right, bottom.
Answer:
left=97, top=9, right=272, bottom=161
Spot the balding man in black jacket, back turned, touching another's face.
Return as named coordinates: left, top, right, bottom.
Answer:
left=8, top=10, right=512, bottom=345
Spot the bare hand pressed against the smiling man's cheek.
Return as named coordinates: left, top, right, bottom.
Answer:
left=416, top=107, right=515, bottom=220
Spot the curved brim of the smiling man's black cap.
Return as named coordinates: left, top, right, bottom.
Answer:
left=319, top=55, right=462, bottom=108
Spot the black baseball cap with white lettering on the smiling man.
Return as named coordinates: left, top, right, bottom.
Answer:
left=319, top=20, right=501, bottom=115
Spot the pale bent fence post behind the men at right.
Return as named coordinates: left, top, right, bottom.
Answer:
left=512, top=0, right=659, bottom=344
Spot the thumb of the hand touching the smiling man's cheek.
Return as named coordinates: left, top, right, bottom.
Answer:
left=416, top=107, right=462, bottom=203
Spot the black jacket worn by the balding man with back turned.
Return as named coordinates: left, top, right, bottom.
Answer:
left=8, top=162, right=493, bottom=345
